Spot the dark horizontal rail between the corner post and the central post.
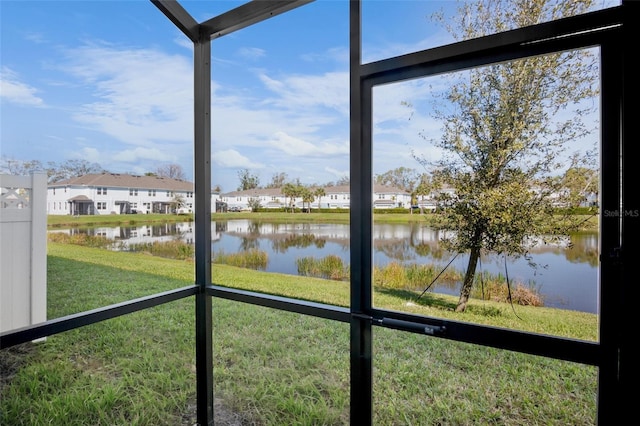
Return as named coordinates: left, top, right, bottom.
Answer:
left=207, top=286, right=351, bottom=322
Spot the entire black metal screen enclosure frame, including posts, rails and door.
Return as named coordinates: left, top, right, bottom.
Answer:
left=0, top=0, right=640, bottom=425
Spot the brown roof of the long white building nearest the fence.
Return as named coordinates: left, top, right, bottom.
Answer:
left=49, top=173, right=194, bottom=191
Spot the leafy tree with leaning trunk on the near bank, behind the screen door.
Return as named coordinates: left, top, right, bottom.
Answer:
left=419, top=0, right=597, bottom=312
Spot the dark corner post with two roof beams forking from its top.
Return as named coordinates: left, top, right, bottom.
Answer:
left=152, top=0, right=318, bottom=425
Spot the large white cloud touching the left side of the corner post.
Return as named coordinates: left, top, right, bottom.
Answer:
left=66, top=45, right=193, bottom=147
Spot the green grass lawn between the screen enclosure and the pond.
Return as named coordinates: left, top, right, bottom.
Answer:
left=0, top=243, right=597, bottom=425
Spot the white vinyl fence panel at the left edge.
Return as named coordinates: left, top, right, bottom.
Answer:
left=0, top=173, right=47, bottom=332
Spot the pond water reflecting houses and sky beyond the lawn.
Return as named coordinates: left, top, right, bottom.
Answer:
left=56, top=220, right=599, bottom=313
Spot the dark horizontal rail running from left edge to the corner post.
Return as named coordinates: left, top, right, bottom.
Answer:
left=0, top=286, right=199, bottom=349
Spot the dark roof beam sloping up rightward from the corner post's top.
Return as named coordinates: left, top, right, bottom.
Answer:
left=202, top=0, right=313, bottom=39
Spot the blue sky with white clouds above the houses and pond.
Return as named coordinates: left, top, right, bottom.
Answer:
left=0, top=0, right=608, bottom=192
